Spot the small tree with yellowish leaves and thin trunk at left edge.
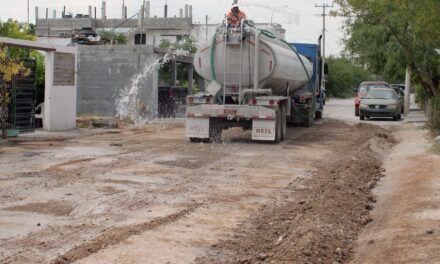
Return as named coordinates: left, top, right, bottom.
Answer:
left=0, top=47, right=30, bottom=139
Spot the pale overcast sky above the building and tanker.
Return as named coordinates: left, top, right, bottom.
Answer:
left=0, top=0, right=343, bottom=55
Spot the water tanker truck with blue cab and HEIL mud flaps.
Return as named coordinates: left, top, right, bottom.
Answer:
left=185, top=21, right=325, bottom=142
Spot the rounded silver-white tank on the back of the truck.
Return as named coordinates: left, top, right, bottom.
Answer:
left=194, top=26, right=313, bottom=96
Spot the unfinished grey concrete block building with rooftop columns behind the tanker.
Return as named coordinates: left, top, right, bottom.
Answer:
left=35, top=1, right=285, bottom=117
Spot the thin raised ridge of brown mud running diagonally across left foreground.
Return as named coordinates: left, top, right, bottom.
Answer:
left=51, top=203, right=202, bottom=264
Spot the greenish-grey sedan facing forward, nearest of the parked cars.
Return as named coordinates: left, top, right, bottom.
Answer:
left=359, top=88, right=402, bottom=121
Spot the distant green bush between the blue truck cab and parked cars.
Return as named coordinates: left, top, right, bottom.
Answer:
left=326, top=56, right=372, bottom=98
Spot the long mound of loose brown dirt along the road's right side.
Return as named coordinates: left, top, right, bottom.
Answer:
left=197, top=124, right=396, bottom=264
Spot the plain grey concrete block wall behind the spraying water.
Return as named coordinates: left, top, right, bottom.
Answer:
left=78, top=45, right=160, bottom=117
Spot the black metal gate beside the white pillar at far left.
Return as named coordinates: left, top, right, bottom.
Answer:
left=0, top=60, right=37, bottom=133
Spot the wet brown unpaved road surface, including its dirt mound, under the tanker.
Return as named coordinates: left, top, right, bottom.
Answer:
left=0, top=97, right=436, bottom=264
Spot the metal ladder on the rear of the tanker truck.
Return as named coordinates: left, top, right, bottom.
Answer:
left=223, top=22, right=243, bottom=104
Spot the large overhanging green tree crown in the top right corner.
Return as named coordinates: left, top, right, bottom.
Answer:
left=334, top=0, right=440, bottom=128
